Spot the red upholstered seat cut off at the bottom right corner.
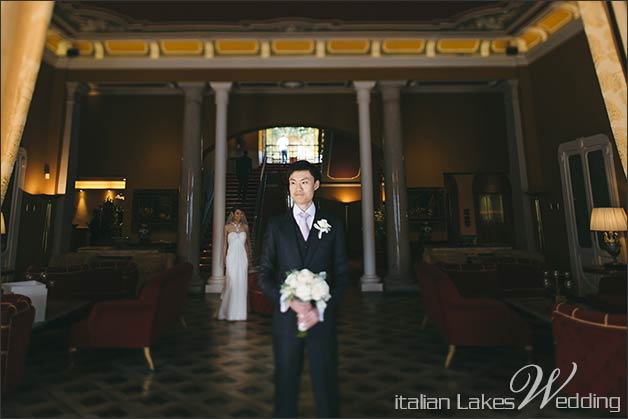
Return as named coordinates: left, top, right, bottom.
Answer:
left=552, top=303, right=627, bottom=417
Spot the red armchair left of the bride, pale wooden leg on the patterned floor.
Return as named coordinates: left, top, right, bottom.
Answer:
left=69, top=263, right=192, bottom=370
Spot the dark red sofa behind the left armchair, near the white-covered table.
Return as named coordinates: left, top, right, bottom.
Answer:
left=25, top=260, right=138, bottom=301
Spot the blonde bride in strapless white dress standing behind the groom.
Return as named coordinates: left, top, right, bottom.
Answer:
left=216, top=207, right=251, bottom=321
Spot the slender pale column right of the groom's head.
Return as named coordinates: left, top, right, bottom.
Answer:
left=353, top=81, right=383, bottom=292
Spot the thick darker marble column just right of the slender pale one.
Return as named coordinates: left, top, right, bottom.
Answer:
left=378, top=80, right=418, bottom=291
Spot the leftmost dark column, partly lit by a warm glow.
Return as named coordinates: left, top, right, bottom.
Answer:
left=52, top=82, right=87, bottom=255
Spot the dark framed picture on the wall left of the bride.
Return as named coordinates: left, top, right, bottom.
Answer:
left=132, top=189, right=179, bottom=231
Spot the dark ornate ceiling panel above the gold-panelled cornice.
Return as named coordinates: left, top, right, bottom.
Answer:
left=53, top=1, right=549, bottom=37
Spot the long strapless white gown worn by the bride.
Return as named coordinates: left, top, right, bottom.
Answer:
left=217, top=231, right=249, bottom=320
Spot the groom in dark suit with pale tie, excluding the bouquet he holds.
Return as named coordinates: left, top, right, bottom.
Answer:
left=259, top=160, right=348, bottom=418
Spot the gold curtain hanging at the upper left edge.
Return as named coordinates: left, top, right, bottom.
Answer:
left=0, top=1, right=54, bottom=201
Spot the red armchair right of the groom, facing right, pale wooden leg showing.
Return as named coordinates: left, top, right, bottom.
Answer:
left=416, top=262, right=532, bottom=368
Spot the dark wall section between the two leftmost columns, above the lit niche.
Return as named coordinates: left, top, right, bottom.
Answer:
left=78, top=95, right=183, bottom=241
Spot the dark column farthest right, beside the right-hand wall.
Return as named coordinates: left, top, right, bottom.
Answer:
left=500, top=80, right=536, bottom=252
